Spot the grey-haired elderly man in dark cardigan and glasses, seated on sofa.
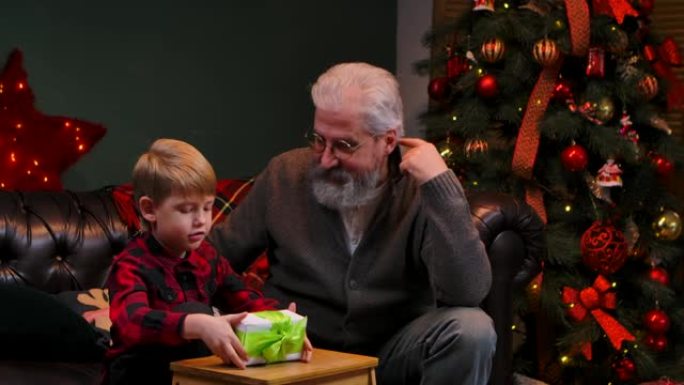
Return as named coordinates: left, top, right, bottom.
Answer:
left=213, top=63, right=496, bottom=384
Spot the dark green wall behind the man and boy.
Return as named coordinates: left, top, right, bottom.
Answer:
left=0, top=0, right=397, bottom=190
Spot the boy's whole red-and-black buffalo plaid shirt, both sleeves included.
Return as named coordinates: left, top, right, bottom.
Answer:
left=107, top=234, right=277, bottom=358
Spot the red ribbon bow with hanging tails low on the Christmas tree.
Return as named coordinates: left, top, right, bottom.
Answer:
left=562, top=275, right=636, bottom=360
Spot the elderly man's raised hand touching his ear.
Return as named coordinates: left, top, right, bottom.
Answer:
left=399, top=138, right=449, bottom=184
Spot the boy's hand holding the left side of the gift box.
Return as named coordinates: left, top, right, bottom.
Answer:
left=183, top=312, right=247, bottom=369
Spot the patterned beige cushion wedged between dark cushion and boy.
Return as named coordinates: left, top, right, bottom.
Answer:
left=55, top=288, right=112, bottom=349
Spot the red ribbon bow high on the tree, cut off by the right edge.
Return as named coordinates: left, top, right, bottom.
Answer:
left=644, top=36, right=684, bottom=109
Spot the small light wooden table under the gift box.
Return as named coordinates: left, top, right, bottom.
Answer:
left=171, top=349, right=378, bottom=385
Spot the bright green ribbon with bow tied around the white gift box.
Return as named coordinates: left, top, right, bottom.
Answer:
left=235, top=311, right=306, bottom=363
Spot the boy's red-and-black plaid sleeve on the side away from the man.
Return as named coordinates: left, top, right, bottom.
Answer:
left=107, top=249, right=186, bottom=350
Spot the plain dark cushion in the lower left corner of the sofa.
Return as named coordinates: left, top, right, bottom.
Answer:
left=0, top=285, right=104, bottom=362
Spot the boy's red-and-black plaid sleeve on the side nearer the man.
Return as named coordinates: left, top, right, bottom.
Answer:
left=216, top=246, right=278, bottom=313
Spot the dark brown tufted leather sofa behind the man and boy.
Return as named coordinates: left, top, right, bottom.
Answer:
left=0, top=184, right=545, bottom=385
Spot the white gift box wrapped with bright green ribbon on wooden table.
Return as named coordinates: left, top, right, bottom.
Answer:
left=235, top=310, right=306, bottom=366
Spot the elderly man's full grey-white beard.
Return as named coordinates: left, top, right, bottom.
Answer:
left=311, top=166, right=380, bottom=210
